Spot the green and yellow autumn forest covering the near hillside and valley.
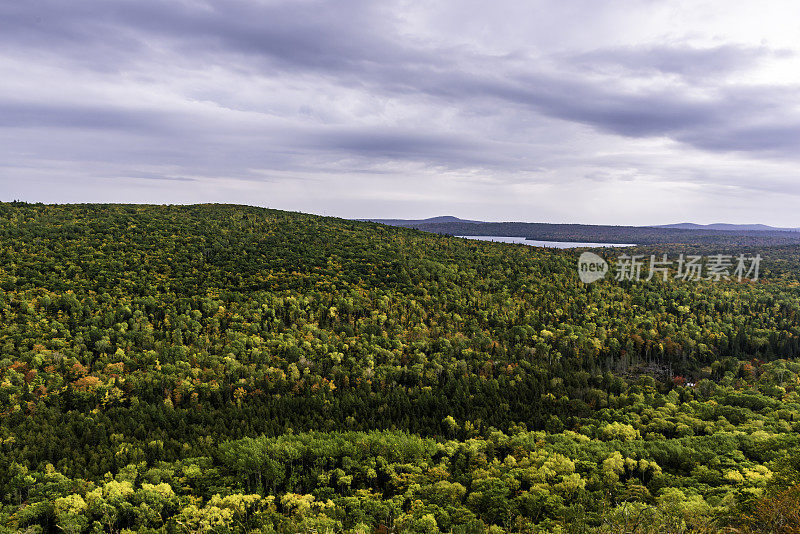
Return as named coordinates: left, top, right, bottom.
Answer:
left=0, top=203, right=800, bottom=533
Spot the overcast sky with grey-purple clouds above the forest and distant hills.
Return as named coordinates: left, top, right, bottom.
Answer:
left=0, top=0, right=800, bottom=226
